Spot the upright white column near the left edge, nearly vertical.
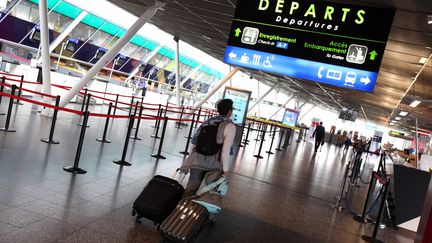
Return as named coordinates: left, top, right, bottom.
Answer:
left=39, top=0, right=51, bottom=115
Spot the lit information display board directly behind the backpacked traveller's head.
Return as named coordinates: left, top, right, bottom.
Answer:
left=224, top=87, right=252, bottom=125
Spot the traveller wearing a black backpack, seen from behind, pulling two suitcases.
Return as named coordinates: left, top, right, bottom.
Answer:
left=180, top=99, right=236, bottom=198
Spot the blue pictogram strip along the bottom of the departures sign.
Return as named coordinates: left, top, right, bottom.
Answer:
left=224, top=46, right=378, bottom=93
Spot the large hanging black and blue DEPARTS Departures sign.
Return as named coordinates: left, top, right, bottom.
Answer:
left=224, top=0, right=395, bottom=92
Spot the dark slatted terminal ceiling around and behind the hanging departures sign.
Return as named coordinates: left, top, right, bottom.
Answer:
left=110, top=0, right=432, bottom=130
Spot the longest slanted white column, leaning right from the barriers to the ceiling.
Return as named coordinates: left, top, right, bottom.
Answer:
left=60, top=1, right=165, bottom=107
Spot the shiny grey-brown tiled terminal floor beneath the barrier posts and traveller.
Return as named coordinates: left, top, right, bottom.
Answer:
left=0, top=99, right=414, bottom=243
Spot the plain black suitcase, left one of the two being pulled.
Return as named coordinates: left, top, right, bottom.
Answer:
left=132, top=175, right=184, bottom=224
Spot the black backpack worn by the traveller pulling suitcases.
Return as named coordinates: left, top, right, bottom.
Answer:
left=195, top=122, right=222, bottom=155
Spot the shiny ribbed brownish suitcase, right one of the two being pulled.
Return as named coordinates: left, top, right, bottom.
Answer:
left=159, top=200, right=209, bottom=243
